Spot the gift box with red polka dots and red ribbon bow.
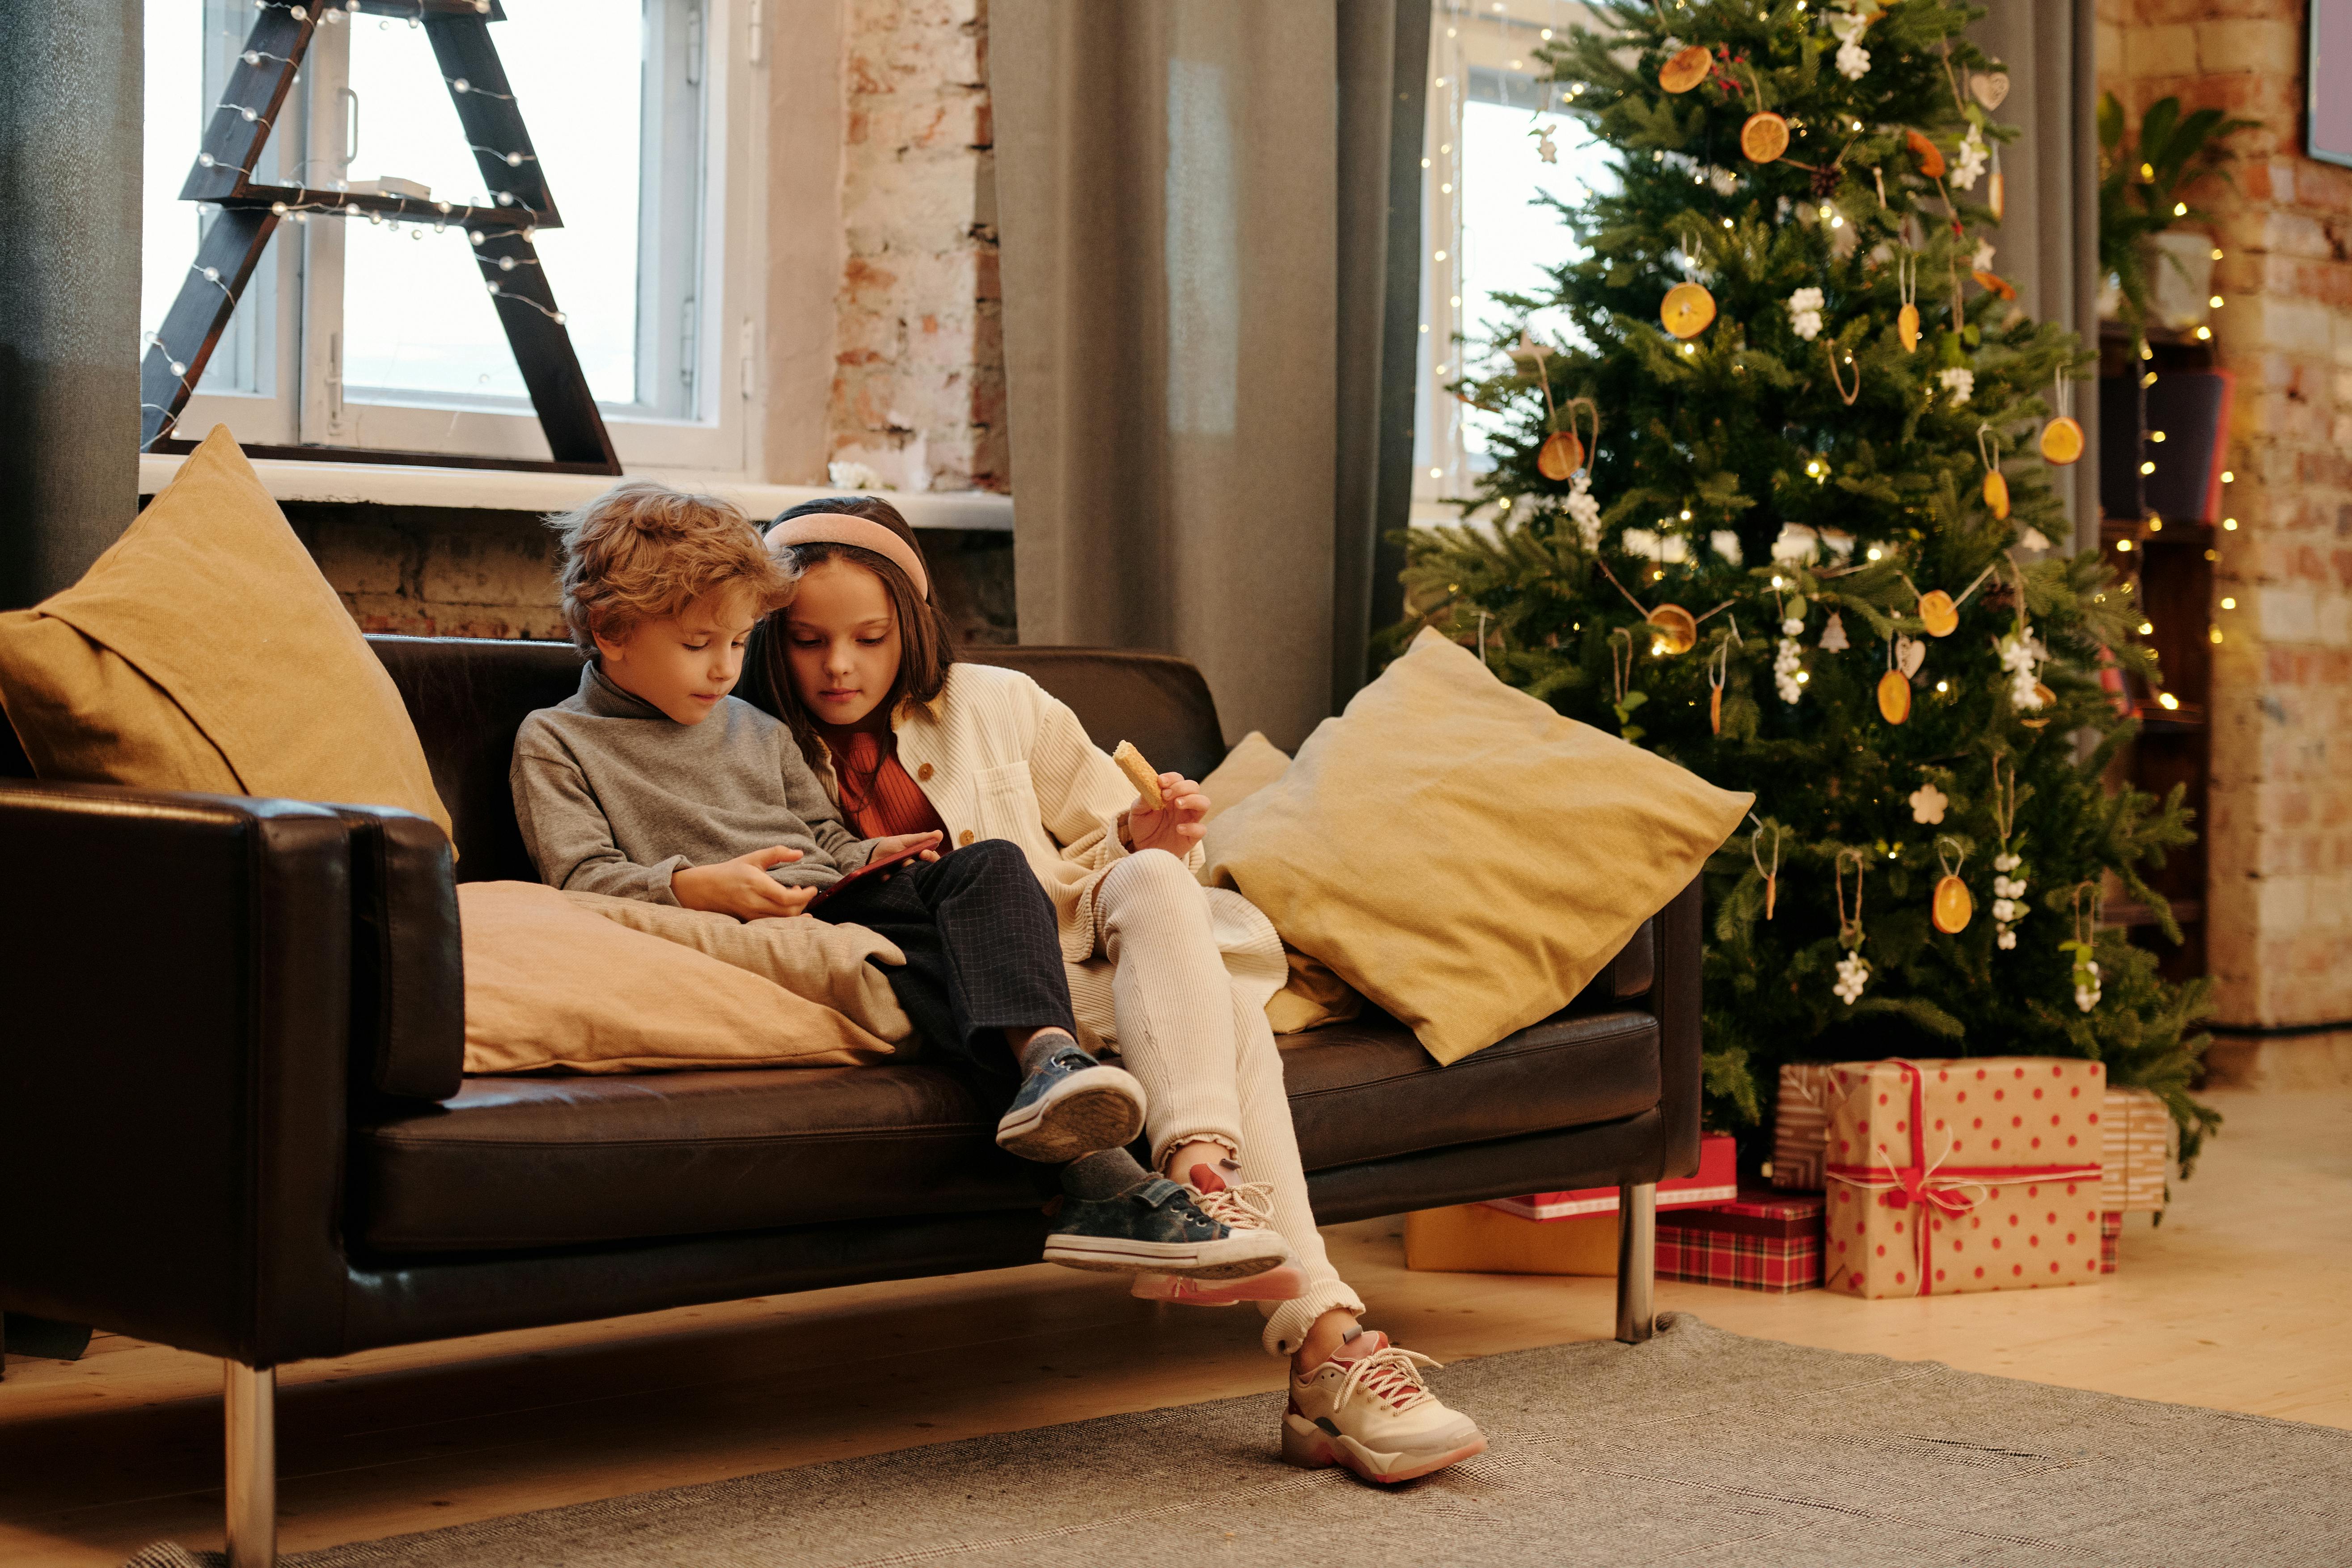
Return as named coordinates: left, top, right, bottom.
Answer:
left=1820, top=1056, right=2107, bottom=1298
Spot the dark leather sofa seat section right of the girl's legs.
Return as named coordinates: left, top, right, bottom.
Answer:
left=1279, top=1009, right=1658, bottom=1171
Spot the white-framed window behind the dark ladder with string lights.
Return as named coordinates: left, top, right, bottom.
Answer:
left=141, top=0, right=755, bottom=473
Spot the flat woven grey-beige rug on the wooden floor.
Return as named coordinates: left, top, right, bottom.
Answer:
left=132, top=1314, right=2352, bottom=1568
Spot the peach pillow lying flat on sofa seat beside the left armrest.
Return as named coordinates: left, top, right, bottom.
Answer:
left=456, top=882, right=894, bottom=1072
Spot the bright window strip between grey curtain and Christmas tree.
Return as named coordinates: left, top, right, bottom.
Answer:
left=1413, top=0, right=1607, bottom=522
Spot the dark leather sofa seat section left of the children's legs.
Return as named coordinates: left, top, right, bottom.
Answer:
left=355, top=1063, right=1051, bottom=1253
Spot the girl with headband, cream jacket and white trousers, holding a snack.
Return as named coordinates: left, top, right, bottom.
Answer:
left=743, top=496, right=1486, bottom=1481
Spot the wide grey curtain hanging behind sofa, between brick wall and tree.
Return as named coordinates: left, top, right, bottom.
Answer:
left=988, top=0, right=1428, bottom=748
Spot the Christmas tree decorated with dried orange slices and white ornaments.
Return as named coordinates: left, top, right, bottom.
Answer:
left=1400, top=0, right=2218, bottom=1154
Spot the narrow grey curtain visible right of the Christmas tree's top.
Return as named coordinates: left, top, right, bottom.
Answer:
left=1973, top=0, right=2098, bottom=550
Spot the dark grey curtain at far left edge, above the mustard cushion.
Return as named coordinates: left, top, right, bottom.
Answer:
left=0, top=0, right=144, bottom=609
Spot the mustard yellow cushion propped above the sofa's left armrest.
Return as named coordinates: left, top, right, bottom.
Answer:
left=0, top=426, right=449, bottom=832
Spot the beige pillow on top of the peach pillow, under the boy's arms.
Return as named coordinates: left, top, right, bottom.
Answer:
left=564, top=893, right=915, bottom=1056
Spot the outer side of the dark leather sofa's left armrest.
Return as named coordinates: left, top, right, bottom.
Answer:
left=0, top=781, right=351, bottom=1366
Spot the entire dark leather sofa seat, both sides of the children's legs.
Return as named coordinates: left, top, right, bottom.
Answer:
left=353, top=1011, right=1658, bottom=1255
